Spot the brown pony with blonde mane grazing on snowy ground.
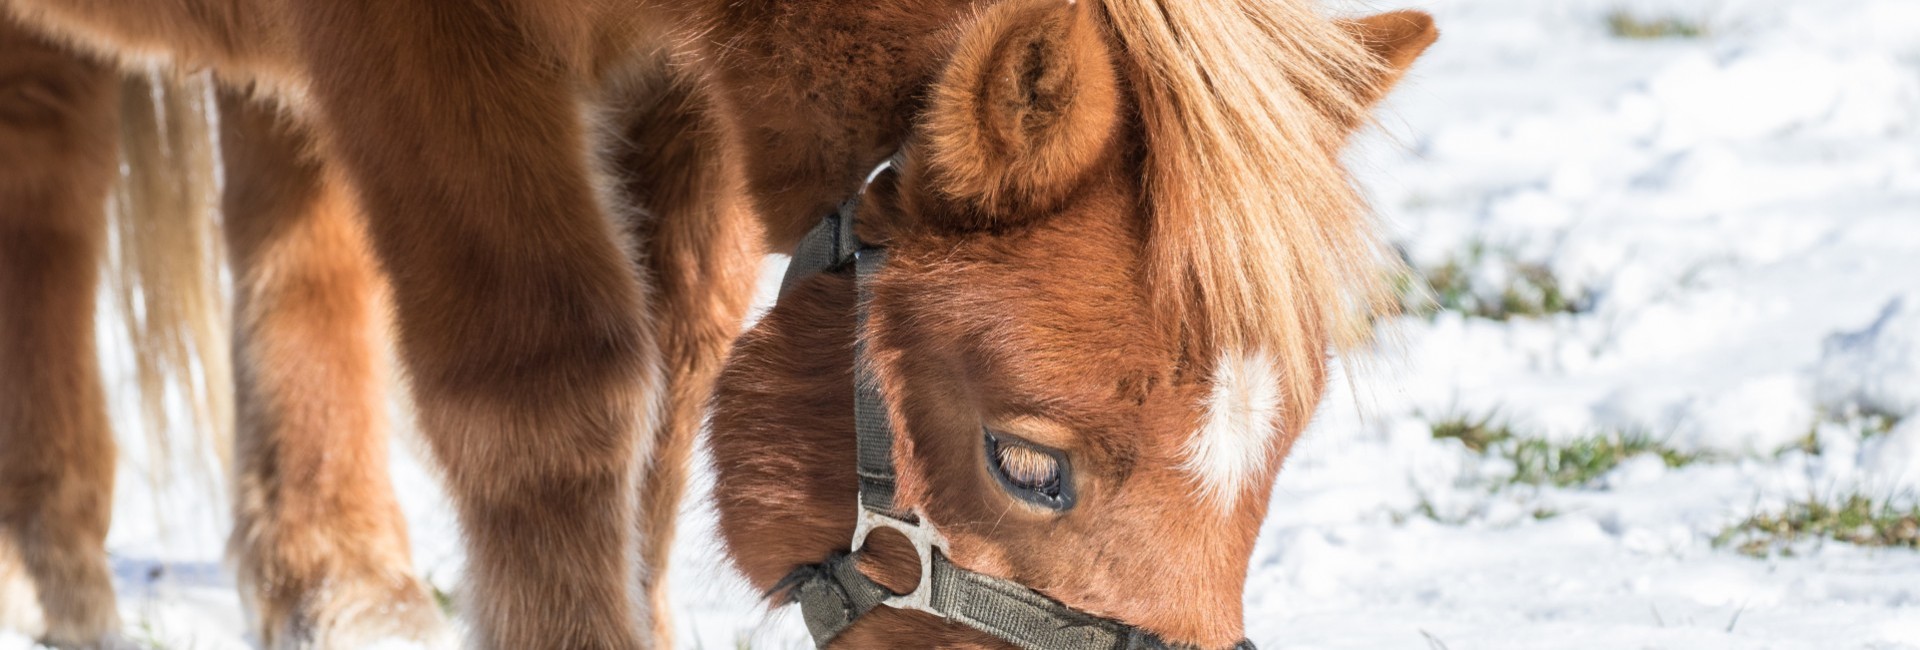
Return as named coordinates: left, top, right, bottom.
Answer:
left=0, top=0, right=1432, bottom=648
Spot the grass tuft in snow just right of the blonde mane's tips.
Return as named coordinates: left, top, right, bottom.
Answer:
left=1396, top=242, right=1590, bottom=320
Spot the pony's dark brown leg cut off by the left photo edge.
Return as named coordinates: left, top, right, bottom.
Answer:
left=0, top=17, right=119, bottom=646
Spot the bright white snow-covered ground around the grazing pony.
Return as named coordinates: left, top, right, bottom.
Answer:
left=0, top=0, right=1920, bottom=650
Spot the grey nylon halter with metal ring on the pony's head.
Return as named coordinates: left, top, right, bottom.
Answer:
left=774, top=179, right=1254, bottom=650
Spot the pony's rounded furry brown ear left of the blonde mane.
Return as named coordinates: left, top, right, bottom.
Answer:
left=922, top=0, right=1119, bottom=226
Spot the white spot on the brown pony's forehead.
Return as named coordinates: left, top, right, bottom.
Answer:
left=1181, top=353, right=1281, bottom=510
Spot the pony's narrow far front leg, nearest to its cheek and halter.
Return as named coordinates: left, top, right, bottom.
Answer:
left=616, top=75, right=764, bottom=646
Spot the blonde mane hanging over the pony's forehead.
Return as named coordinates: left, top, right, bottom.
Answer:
left=1100, top=0, right=1396, bottom=422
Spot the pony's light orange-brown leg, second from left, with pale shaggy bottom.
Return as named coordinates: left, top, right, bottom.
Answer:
left=221, top=92, right=445, bottom=648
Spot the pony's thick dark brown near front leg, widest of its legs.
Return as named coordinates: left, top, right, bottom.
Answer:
left=290, top=0, right=659, bottom=648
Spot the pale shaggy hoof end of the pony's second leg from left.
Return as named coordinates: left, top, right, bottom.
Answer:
left=261, top=577, right=453, bottom=650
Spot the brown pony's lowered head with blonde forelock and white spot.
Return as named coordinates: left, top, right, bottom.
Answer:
left=712, top=0, right=1436, bottom=648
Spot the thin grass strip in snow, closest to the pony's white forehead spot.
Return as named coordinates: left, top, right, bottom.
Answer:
left=1432, top=414, right=1701, bottom=487
